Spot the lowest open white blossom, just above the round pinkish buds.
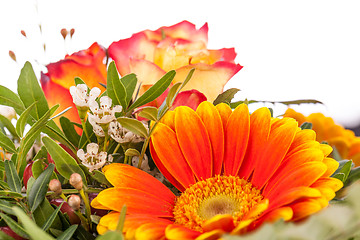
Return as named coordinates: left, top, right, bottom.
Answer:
left=77, top=143, right=107, bottom=172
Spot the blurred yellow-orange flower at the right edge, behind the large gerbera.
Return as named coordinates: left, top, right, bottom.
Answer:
left=284, top=108, right=360, bottom=166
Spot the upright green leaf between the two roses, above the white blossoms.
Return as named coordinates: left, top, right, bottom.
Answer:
left=106, top=61, right=127, bottom=110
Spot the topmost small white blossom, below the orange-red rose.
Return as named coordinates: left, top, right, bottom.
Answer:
left=70, top=84, right=101, bottom=107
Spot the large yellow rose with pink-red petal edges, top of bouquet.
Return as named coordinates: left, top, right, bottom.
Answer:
left=108, top=21, right=242, bottom=101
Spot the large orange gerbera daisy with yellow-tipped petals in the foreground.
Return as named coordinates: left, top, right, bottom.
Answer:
left=92, top=102, right=342, bottom=239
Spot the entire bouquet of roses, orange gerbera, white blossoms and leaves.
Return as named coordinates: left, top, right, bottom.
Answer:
left=0, top=21, right=360, bottom=240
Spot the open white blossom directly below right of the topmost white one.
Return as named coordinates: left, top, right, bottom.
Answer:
left=88, top=96, right=122, bottom=125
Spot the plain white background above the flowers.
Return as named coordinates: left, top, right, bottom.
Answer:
left=0, top=0, right=360, bottom=127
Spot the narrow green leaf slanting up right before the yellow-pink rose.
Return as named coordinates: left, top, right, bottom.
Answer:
left=127, top=70, right=176, bottom=112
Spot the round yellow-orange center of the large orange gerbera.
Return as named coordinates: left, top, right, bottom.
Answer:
left=173, top=176, right=263, bottom=232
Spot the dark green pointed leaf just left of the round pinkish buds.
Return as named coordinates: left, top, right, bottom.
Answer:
left=28, top=164, right=55, bottom=212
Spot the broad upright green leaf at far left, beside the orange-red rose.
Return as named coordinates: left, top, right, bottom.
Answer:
left=17, top=62, right=49, bottom=120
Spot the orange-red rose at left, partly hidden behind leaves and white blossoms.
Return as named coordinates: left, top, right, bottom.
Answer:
left=40, top=42, right=107, bottom=123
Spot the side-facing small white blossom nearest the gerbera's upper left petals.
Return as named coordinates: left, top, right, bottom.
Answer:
left=108, top=121, right=147, bottom=143
